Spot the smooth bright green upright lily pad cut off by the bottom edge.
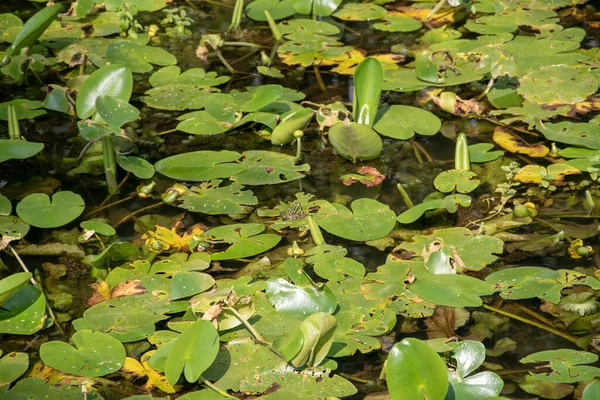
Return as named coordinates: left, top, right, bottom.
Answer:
left=386, top=338, right=448, bottom=400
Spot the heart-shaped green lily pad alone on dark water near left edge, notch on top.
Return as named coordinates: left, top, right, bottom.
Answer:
left=17, top=191, right=85, bottom=228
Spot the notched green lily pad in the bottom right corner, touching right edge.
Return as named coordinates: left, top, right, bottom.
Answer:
left=519, top=349, right=600, bottom=383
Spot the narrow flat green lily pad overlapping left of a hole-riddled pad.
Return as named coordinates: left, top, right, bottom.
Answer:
left=154, top=150, right=246, bottom=181
